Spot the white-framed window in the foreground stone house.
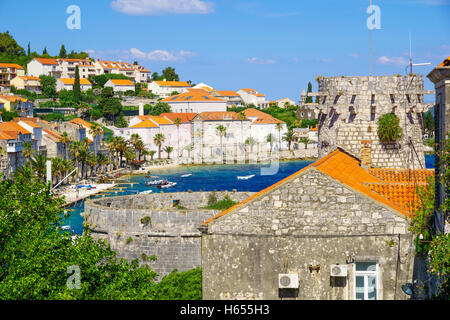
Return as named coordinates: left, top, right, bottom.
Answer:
left=355, top=262, right=378, bottom=300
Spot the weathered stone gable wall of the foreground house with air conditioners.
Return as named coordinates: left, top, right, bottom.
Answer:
left=202, top=168, right=414, bottom=300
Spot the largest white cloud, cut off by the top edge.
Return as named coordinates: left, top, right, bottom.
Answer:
left=111, top=0, right=214, bottom=15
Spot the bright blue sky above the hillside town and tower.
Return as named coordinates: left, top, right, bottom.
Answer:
left=0, top=0, right=450, bottom=101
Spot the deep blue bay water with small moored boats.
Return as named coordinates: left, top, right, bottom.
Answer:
left=64, top=155, right=434, bottom=234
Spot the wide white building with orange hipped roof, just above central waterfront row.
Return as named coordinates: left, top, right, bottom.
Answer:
left=161, top=89, right=227, bottom=113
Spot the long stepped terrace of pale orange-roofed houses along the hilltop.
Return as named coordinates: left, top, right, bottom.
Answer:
left=95, top=60, right=151, bottom=83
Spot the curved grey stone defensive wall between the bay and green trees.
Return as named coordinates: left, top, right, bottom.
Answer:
left=83, top=191, right=253, bottom=279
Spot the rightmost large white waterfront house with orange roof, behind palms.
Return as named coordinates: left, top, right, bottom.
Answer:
left=242, top=108, right=287, bottom=151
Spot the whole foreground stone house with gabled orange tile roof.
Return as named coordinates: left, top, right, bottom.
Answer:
left=201, top=148, right=433, bottom=300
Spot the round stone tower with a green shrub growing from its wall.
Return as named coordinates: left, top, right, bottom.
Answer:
left=300, top=75, right=433, bottom=169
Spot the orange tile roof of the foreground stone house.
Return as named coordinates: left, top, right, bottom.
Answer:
left=203, top=148, right=434, bottom=225
